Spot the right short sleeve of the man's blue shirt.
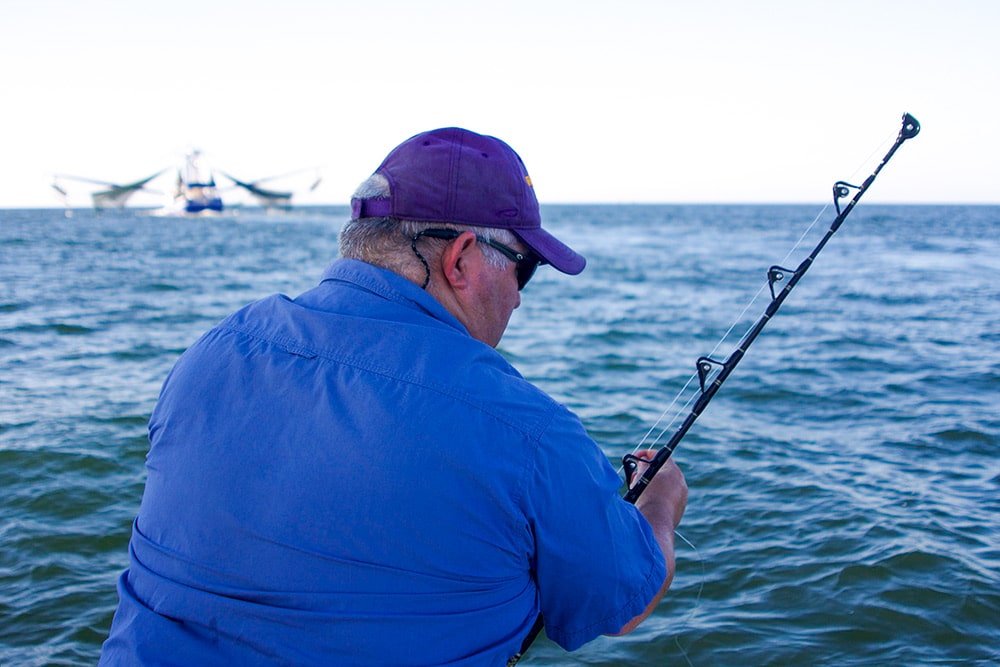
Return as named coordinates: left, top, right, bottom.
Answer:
left=527, top=409, right=666, bottom=651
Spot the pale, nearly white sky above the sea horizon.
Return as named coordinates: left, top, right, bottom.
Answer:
left=0, top=0, right=1000, bottom=208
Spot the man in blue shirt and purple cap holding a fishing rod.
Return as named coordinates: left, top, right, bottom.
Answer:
left=102, top=128, right=687, bottom=665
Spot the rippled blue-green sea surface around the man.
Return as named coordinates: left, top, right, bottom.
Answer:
left=0, top=202, right=1000, bottom=667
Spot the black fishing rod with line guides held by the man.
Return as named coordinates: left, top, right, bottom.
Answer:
left=507, top=113, right=920, bottom=667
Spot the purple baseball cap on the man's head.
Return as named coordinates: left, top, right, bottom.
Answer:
left=351, top=127, right=587, bottom=275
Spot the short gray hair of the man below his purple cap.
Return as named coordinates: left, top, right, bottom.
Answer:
left=340, top=174, right=517, bottom=284
